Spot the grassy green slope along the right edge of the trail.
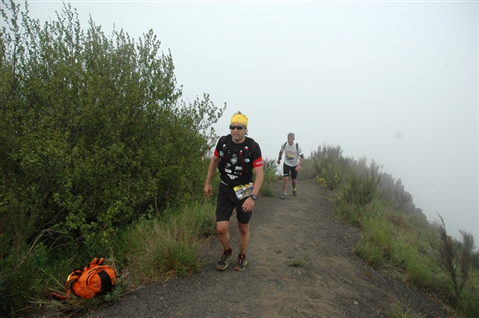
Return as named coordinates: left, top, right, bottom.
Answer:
left=316, top=151, right=479, bottom=317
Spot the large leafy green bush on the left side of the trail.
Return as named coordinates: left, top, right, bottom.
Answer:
left=0, top=0, right=225, bottom=315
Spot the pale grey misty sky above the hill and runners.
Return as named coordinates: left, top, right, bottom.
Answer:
left=20, top=0, right=479, bottom=245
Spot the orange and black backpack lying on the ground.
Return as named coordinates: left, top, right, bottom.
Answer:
left=52, top=257, right=116, bottom=300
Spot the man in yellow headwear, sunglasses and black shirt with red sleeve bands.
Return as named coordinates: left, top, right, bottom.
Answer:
left=204, top=112, right=263, bottom=271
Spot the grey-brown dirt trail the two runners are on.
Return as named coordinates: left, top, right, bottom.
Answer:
left=81, top=180, right=448, bottom=318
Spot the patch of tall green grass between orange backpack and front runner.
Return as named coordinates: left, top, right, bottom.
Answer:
left=124, top=200, right=216, bottom=285
